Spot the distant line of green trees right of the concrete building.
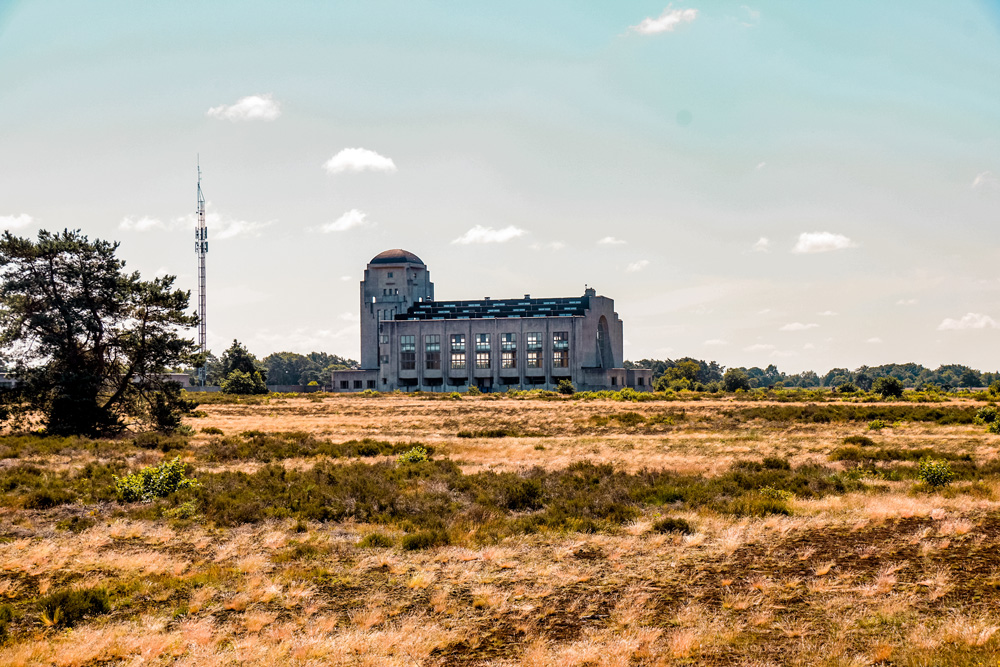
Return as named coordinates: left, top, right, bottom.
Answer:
left=625, top=357, right=1000, bottom=391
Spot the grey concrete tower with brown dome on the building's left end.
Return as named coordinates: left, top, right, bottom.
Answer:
left=361, top=248, right=434, bottom=369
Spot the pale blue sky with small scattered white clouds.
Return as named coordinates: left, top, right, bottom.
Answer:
left=0, top=0, right=1000, bottom=372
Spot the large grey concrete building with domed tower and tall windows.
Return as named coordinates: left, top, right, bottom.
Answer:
left=332, top=249, right=652, bottom=391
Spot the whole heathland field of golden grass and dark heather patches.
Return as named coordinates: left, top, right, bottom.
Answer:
left=0, top=391, right=1000, bottom=667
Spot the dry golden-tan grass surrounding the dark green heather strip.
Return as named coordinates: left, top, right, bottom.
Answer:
left=0, top=396, right=1000, bottom=667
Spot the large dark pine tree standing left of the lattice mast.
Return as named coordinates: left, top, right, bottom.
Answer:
left=0, top=230, right=197, bottom=437
